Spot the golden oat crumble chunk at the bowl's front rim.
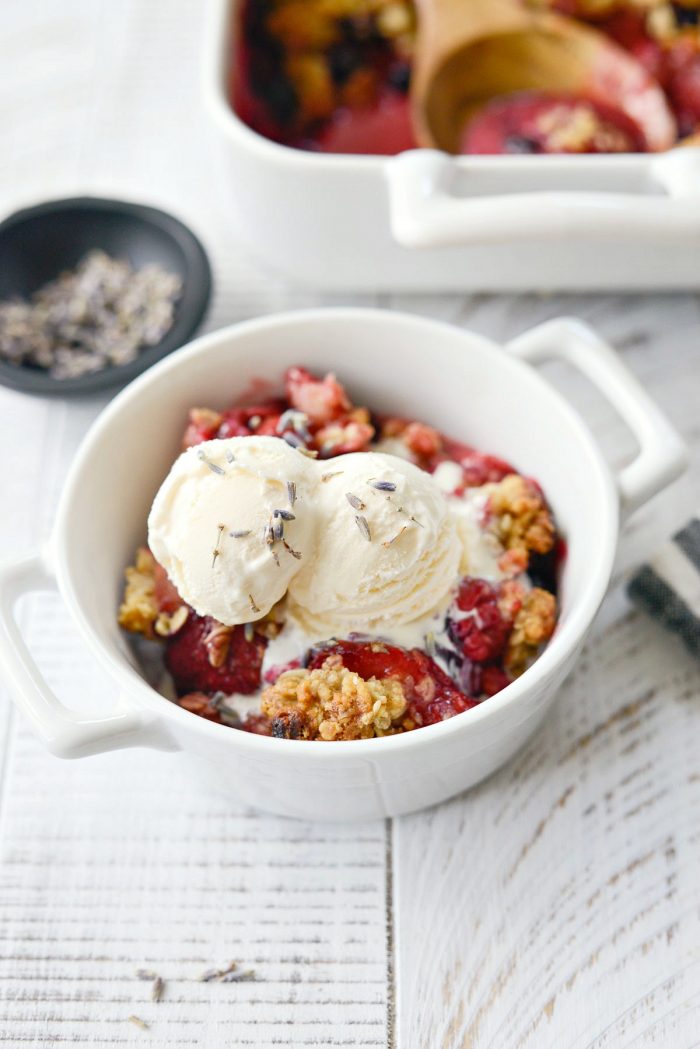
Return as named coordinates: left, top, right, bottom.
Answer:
left=260, top=656, right=406, bottom=740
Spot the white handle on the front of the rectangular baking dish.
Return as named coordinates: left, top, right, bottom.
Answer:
left=386, top=148, right=700, bottom=248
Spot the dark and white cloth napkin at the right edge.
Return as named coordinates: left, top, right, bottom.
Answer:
left=629, top=516, right=700, bottom=659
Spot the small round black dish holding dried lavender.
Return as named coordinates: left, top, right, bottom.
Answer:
left=0, top=197, right=211, bottom=397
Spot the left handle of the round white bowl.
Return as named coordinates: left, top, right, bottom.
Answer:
left=0, top=553, right=175, bottom=757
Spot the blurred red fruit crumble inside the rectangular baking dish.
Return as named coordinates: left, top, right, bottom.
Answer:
left=230, top=0, right=700, bottom=154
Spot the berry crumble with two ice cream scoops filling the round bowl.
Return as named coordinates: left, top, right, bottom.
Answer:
left=119, top=367, right=564, bottom=741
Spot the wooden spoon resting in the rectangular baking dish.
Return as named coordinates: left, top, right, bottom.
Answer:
left=411, top=0, right=676, bottom=153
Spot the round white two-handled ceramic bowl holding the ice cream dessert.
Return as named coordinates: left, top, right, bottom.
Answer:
left=0, top=309, right=685, bottom=819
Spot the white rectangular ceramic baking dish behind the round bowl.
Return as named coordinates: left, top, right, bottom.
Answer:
left=204, top=0, right=700, bottom=291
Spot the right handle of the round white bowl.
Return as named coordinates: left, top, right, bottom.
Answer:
left=507, top=317, right=687, bottom=517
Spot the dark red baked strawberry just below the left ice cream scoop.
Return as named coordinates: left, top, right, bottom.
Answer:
left=165, top=612, right=268, bottom=695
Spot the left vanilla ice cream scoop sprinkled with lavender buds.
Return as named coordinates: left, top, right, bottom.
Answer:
left=148, top=436, right=316, bottom=625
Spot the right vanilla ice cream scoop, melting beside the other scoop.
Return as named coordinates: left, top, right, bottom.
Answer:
left=289, top=452, right=461, bottom=638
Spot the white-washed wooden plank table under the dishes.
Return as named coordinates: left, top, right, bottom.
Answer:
left=0, top=0, right=700, bottom=1049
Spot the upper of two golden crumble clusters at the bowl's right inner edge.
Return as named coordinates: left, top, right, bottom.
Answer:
left=489, top=473, right=556, bottom=554
